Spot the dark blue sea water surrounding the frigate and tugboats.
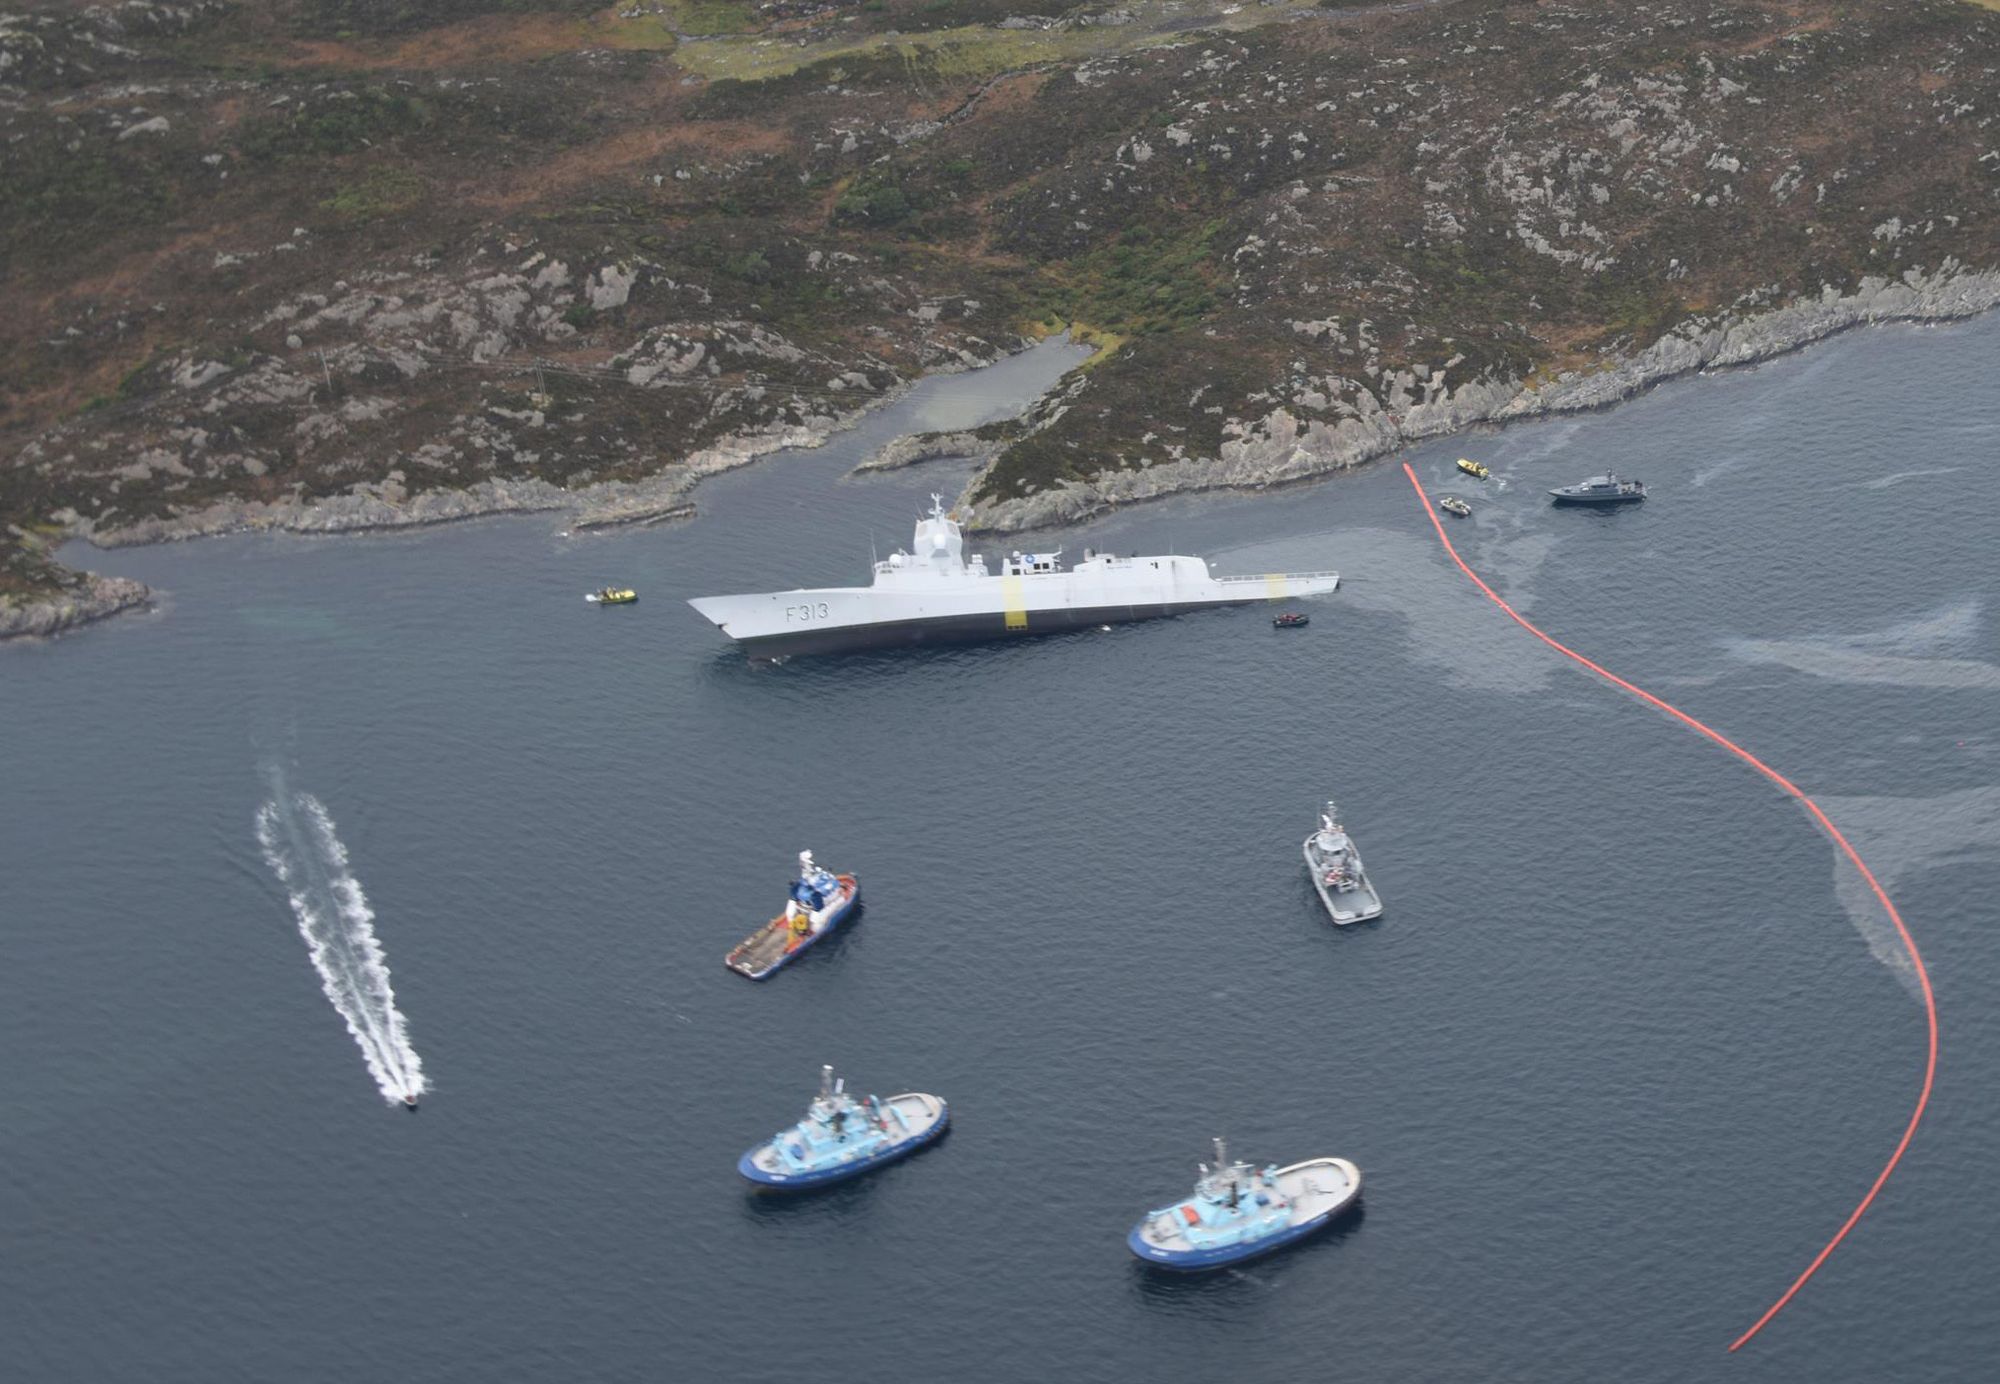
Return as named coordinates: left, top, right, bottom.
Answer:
left=0, top=320, right=2000, bottom=1384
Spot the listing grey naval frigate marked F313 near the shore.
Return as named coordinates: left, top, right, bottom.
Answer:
left=688, top=496, right=1340, bottom=658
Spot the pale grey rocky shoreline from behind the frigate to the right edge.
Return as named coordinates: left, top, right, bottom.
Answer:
left=952, top=260, right=2000, bottom=532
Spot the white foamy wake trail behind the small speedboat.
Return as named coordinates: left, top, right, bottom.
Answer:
left=256, top=784, right=426, bottom=1104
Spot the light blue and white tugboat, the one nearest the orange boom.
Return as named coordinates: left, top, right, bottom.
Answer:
left=1126, top=1138, right=1362, bottom=1270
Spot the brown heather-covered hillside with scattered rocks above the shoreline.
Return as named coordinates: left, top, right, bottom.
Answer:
left=0, top=0, right=2000, bottom=598
